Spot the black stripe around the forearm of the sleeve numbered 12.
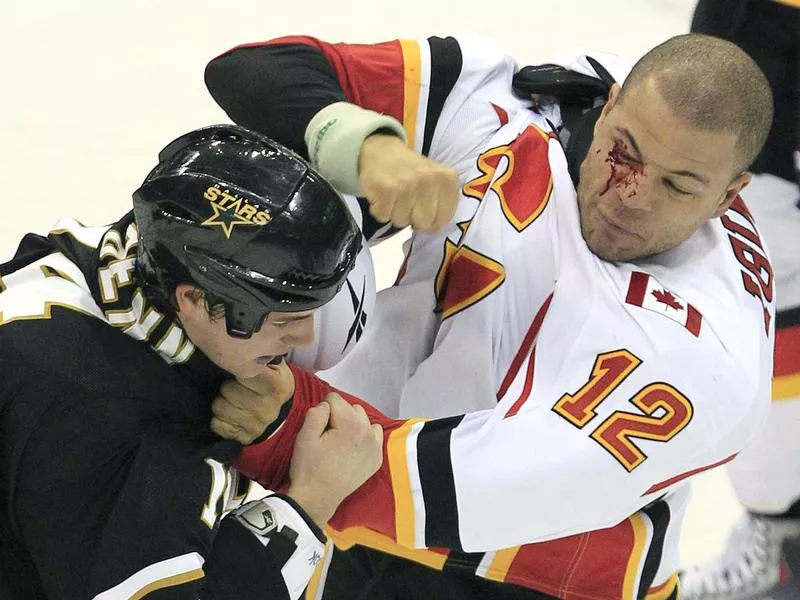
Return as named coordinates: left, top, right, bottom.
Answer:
left=417, top=415, right=464, bottom=550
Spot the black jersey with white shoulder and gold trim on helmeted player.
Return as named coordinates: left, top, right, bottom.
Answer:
left=0, top=215, right=324, bottom=600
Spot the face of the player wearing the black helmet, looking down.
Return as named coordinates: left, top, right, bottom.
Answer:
left=176, top=286, right=316, bottom=379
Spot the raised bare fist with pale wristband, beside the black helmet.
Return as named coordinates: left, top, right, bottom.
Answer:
left=358, top=133, right=460, bottom=232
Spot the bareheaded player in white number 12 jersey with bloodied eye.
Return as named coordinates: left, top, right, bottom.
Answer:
left=206, top=36, right=775, bottom=600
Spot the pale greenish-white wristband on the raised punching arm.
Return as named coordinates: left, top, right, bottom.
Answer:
left=305, top=102, right=406, bottom=196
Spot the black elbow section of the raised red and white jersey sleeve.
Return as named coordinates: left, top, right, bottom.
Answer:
left=205, top=44, right=346, bottom=158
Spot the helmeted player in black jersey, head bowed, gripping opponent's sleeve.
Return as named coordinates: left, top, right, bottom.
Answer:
left=0, top=126, right=382, bottom=600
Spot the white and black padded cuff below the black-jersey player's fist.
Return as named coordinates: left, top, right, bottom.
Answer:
left=232, top=494, right=325, bottom=600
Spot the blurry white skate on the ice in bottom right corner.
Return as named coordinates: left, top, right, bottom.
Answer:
left=680, top=514, right=800, bottom=600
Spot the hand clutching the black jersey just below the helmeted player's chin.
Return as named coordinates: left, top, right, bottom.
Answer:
left=211, top=361, right=294, bottom=444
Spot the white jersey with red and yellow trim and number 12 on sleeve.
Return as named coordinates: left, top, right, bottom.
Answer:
left=206, top=38, right=775, bottom=600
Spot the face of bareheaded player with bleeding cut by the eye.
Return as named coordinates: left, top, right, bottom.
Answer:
left=578, top=80, right=750, bottom=261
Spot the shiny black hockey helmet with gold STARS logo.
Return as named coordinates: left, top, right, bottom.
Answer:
left=133, top=125, right=361, bottom=338
